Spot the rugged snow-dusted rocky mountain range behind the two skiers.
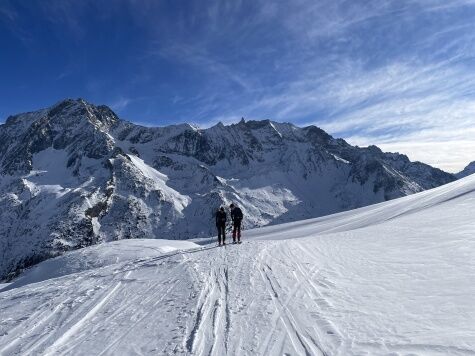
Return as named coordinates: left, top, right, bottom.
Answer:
left=0, top=99, right=455, bottom=279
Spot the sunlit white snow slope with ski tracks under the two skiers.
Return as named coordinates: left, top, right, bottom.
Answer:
left=0, top=176, right=475, bottom=356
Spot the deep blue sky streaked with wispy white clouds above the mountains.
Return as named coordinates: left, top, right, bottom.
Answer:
left=0, top=0, right=475, bottom=172
